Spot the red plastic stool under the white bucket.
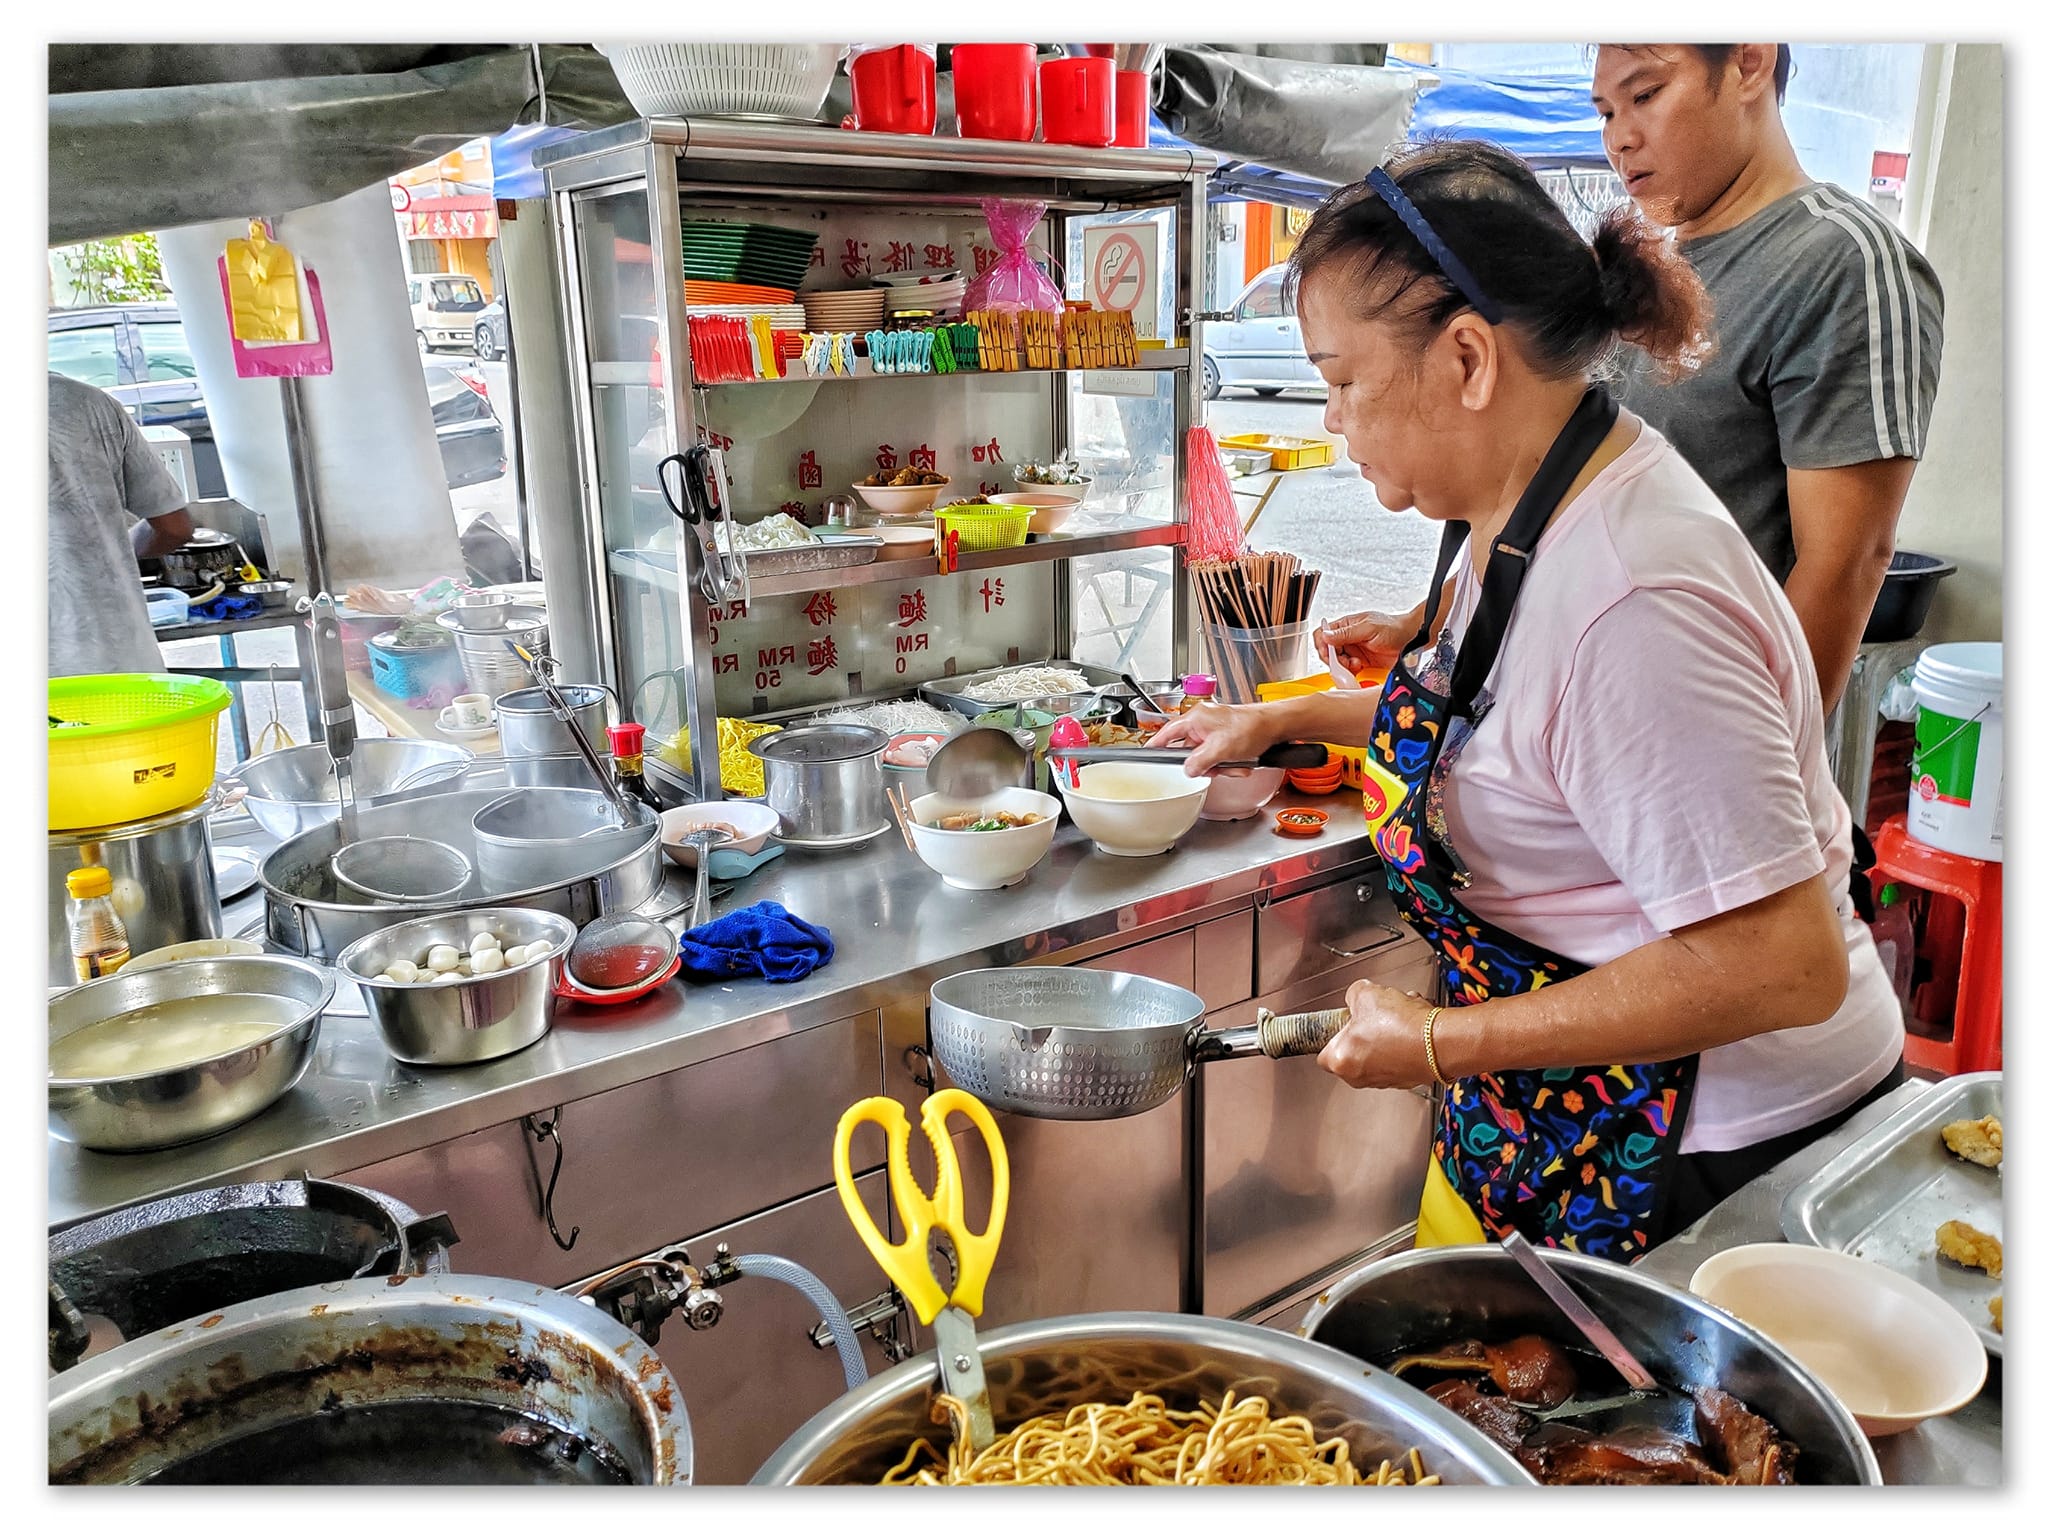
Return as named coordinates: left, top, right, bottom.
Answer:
left=1876, top=815, right=2005, bottom=1077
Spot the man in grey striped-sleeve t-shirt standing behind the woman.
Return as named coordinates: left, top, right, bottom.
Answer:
left=1593, top=43, right=1942, bottom=711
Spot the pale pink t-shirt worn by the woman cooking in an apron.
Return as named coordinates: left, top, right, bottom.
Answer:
left=1444, top=428, right=1905, bottom=1151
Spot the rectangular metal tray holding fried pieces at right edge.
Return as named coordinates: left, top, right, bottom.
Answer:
left=1778, top=1071, right=2005, bottom=1358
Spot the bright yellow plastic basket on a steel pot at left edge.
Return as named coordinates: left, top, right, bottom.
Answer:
left=49, top=672, right=229, bottom=831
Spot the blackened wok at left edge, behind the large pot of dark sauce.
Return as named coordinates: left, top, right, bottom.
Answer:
left=49, top=1180, right=455, bottom=1370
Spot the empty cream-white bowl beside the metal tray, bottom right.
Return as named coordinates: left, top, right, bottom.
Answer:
left=1692, top=1231, right=1987, bottom=1436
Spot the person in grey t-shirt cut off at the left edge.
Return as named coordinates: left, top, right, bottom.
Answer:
left=49, top=373, right=193, bottom=678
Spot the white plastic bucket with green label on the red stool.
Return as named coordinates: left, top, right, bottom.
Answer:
left=1907, top=641, right=2005, bottom=864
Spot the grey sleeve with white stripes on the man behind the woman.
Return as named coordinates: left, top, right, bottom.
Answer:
left=1769, top=186, right=1942, bottom=469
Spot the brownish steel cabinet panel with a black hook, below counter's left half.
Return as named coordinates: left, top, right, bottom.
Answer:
left=342, top=1014, right=883, bottom=1286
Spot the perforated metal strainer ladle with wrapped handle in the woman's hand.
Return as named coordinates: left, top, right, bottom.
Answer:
left=932, top=967, right=1430, bottom=1120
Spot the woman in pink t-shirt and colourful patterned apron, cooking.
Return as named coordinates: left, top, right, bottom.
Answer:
left=1155, top=143, right=1905, bottom=1262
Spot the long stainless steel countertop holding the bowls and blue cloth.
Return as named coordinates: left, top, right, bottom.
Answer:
left=49, top=795, right=1370, bottom=1227
